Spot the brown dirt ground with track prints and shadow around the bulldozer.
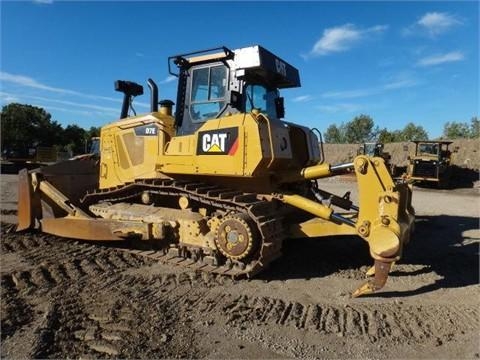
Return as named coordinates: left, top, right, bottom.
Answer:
left=0, top=174, right=480, bottom=359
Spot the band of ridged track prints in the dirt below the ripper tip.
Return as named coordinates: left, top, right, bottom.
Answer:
left=216, top=295, right=480, bottom=344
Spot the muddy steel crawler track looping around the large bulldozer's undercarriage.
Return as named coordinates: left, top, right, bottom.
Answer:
left=81, top=179, right=286, bottom=277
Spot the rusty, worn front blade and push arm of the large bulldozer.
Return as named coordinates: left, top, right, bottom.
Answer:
left=17, top=158, right=162, bottom=241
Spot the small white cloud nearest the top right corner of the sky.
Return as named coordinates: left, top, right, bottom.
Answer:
left=403, top=12, right=463, bottom=36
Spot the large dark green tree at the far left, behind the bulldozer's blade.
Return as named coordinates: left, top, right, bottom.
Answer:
left=0, top=103, right=63, bottom=150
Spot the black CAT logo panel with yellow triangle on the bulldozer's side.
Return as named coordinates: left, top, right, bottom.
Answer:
left=197, top=127, right=238, bottom=156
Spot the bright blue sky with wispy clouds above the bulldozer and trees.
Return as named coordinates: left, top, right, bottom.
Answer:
left=0, top=0, right=479, bottom=137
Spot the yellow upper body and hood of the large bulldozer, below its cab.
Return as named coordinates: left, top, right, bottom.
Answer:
left=99, top=113, right=319, bottom=191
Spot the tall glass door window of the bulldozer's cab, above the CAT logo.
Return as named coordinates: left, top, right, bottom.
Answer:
left=190, top=65, right=228, bottom=123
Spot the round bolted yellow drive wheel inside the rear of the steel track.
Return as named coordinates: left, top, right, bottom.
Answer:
left=215, top=214, right=258, bottom=260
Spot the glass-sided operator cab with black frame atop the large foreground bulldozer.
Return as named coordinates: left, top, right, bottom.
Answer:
left=169, top=45, right=300, bottom=135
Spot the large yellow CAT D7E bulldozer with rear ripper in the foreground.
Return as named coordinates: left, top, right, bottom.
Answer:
left=17, top=46, right=414, bottom=296
